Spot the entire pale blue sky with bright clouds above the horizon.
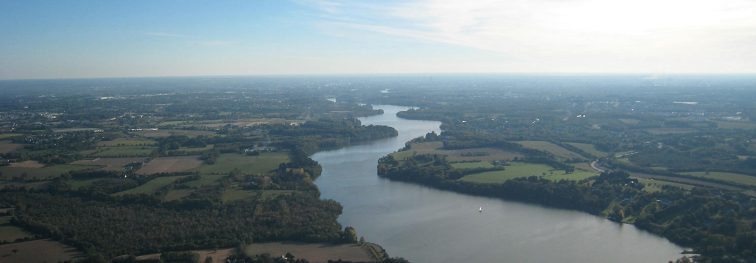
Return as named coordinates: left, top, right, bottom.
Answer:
left=0, top=0, right=756, bottom=79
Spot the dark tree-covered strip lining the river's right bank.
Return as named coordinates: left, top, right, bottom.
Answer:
left=377, top=142, right=752, bottom=260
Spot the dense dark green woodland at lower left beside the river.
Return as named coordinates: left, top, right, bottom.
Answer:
left=0, top=192, right=343, bottom=257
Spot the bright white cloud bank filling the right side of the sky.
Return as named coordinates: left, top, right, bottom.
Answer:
left=306, top=0, right=756, bottom=72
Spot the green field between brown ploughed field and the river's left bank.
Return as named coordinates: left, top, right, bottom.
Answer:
left=198, top=152, right=289, bottom=174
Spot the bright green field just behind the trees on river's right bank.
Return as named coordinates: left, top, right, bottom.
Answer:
left=459, top=162, right=598, bottom=183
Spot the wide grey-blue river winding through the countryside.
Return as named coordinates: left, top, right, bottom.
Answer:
left=312, top=105, right=683, bottom=263
